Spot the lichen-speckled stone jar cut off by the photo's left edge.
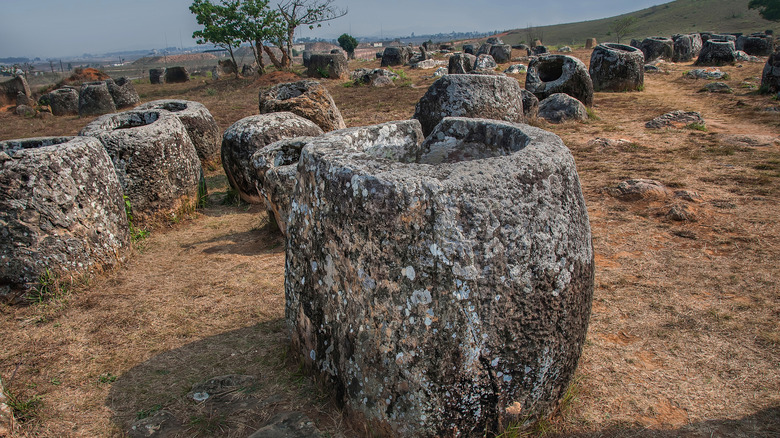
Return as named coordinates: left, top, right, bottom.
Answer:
left=0, top=137, right=130, bottom=301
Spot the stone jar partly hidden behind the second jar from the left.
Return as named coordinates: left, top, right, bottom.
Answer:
left=136, top=99, right=222, bottom=165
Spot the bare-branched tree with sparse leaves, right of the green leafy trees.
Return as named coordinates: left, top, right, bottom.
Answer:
left=278, top=0, right=347, bottom=68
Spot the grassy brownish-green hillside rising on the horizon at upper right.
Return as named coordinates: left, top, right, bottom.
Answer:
left=501, top=0, right=780, bottom=46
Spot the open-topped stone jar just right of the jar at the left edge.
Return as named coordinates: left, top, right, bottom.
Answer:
left=79, top=109, right=205, bottom=225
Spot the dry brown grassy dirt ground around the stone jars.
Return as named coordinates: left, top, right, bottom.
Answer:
left=0, top=50, right=780, bottom=437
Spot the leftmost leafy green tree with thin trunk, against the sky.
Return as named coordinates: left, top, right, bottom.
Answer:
left=190, top=0, right=241, bottom=78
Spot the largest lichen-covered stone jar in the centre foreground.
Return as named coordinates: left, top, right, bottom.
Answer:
left=285, top=118, right=593, bottom=437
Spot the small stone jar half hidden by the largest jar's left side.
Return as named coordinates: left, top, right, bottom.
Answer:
left=251, top=137, right=315, bottom=235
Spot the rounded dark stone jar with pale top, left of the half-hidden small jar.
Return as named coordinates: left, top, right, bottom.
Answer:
left=222, top=112, right=322, bottom=204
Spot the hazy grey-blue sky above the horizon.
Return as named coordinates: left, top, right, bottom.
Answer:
left=0, top=0, right=666, bottom=58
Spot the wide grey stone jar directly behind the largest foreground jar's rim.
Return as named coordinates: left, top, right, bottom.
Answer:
left=413, top=74, right=523, bottom=136
